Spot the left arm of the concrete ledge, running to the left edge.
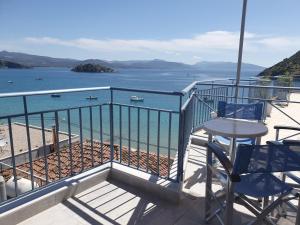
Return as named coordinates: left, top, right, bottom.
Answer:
left=0, top=165, right=110, bottom=225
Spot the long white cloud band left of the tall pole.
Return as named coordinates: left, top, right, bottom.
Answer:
left=25, top=31, right=246, bottom=55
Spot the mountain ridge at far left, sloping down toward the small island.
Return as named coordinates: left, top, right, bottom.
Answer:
left=0, top=51, right=80, bottom=67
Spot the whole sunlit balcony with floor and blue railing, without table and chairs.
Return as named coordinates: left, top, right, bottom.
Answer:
left=0, top=80, right=300, bottom=225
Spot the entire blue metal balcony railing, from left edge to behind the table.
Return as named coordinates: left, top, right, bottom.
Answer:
left=0, top=79, right=300, bottom=204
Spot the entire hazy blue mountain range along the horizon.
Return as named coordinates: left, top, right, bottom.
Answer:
left=0, top=51, right=264, bottom=73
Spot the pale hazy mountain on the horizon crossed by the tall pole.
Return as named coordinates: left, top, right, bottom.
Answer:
left=194, top=61, right=265, bottom=72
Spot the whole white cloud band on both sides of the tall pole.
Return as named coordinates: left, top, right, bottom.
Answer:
left=18, top=31, right=300, bottom=66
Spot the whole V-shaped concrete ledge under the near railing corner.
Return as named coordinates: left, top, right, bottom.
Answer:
left=0, top=163, right=181, bottom=225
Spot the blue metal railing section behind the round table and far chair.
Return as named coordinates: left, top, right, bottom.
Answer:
left=190, top=79, right=300, bottom=133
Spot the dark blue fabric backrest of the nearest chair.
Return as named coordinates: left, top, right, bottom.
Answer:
left=233, top=144, right=300, bottom=175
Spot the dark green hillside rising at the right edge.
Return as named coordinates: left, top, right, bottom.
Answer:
left=258, top=51, right=300, bottom=77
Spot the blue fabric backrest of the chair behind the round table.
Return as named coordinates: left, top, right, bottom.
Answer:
left=218, top=101, right=263, bottom=120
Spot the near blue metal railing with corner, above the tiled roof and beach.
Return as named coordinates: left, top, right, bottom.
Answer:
left=0, top=87, right=184, bottom=204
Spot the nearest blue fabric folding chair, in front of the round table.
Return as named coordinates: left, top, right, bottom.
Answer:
left=205, top=143, right=300, bottom=225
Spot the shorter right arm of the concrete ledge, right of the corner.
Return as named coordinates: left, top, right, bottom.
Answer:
left=109, top=163, right=181, bottom=203
